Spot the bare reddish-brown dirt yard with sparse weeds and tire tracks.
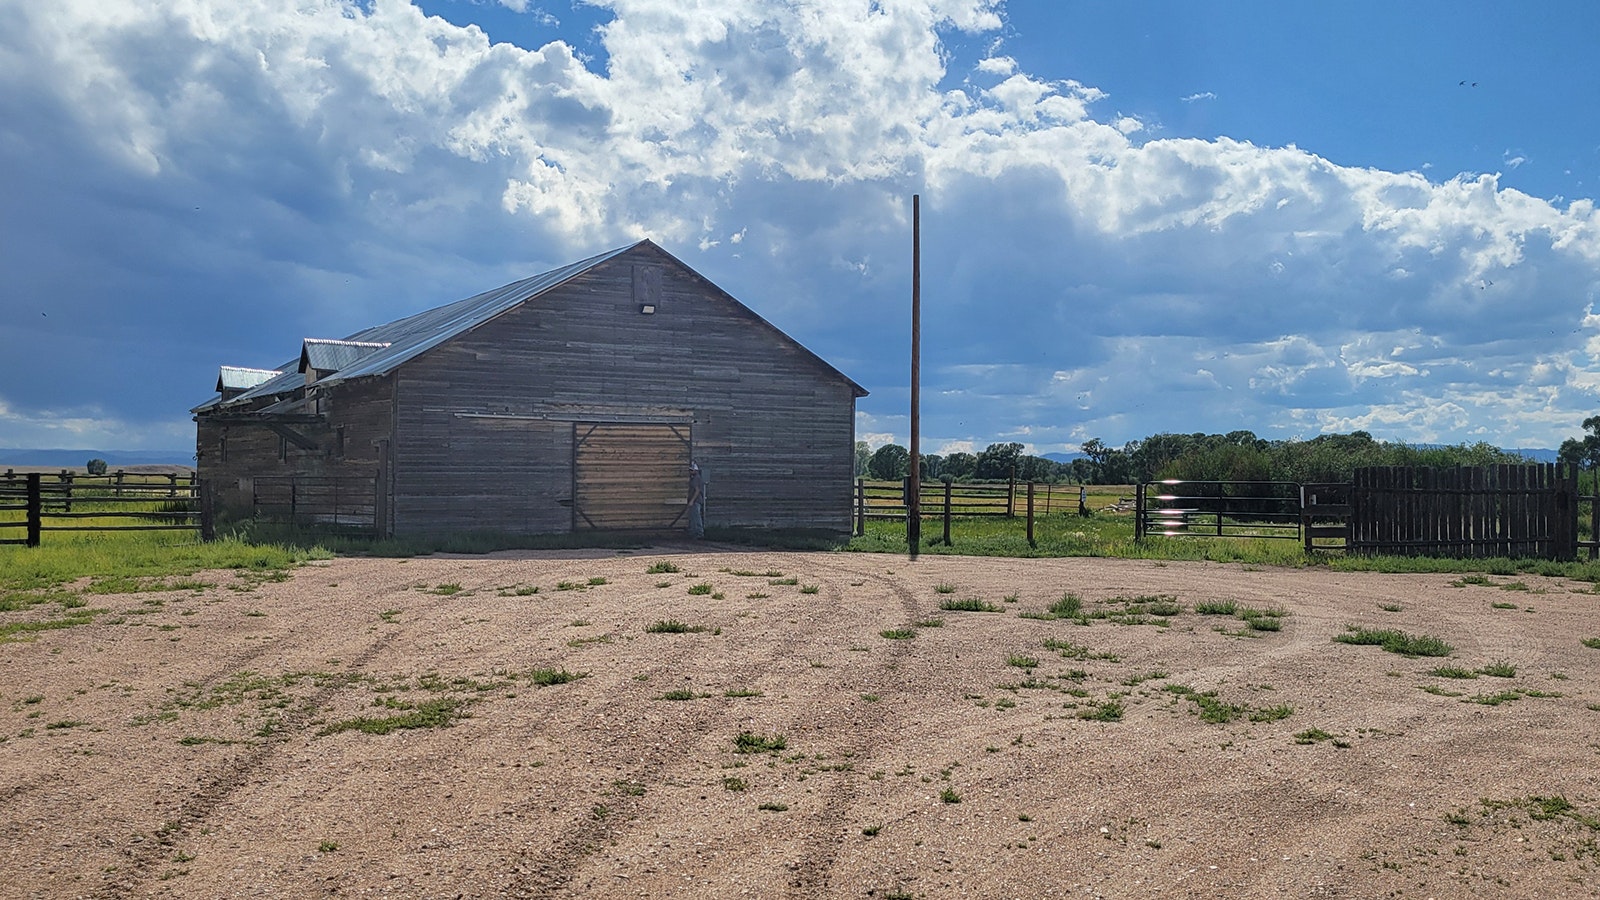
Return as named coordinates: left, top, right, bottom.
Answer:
left=0, top=546, right=1600, bottom=898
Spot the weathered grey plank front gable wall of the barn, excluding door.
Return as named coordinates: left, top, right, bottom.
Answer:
left=392, top=245, right=854, bottom=533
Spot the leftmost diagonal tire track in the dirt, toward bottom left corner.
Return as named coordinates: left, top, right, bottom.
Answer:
left=91, top=633, right=403, bottom=898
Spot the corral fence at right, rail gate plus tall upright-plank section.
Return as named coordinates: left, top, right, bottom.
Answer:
left=1134, top=463, right=1600, bottom=559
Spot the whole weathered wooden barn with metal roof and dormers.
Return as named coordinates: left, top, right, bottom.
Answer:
left=192, top=240, right=866, bottom=535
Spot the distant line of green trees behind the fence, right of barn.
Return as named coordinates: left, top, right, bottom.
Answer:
left=856, top=429, right=1529, bottom=484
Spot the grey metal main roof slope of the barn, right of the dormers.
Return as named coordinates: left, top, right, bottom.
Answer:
left=323, top=242, right=645, bottom=384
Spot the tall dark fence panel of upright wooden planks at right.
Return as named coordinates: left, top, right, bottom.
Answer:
left=1349, top=463, right=1578, bottom=559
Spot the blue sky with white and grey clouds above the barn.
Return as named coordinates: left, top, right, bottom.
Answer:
left=0, top=0, right=1600, bottom=453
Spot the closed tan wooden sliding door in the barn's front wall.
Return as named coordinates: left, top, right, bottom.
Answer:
left=573, top=423, right=690, bottom=532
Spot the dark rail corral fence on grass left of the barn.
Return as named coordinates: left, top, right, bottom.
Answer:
left=0, top=469, right=211, bottom=546
